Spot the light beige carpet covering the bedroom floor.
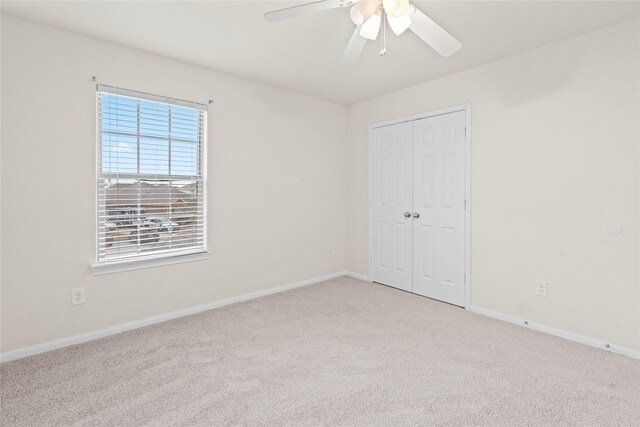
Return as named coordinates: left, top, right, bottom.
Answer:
left=0, top=278, right=640, bottom=426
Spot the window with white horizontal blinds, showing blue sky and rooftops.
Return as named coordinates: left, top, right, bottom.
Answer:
left=93, top=86, right=207, bottom=273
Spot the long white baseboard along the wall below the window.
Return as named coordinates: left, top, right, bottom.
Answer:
left=0, top=271, right=348, bottom=363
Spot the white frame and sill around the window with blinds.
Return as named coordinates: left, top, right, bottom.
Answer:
left=90, top=85, right=209, bottom=275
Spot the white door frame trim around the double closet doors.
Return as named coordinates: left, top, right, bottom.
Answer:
left=367, top=102, right=472, bottom=308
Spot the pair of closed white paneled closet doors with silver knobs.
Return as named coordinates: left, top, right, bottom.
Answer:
left=371, top=111, right=467, bottom=306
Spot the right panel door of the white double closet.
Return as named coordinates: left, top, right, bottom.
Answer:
left=413, top=111, right=466, bottom=306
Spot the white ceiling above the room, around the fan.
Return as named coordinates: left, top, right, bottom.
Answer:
left=2, top=0, right=640, bottom=104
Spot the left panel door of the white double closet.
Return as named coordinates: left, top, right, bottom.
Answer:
left=370, top=123, right=413, bottom=291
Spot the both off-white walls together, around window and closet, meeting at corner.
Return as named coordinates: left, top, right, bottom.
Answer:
left=0, top=16, right=640, bottom=358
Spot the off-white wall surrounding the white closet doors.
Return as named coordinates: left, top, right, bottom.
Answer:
left=347, top=20, right=640, bottom=349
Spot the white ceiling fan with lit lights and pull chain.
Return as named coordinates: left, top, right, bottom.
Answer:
left=264, top=0, right=462, bottom=65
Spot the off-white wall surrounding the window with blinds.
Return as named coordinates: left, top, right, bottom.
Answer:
left=1, top=15, right=346, bottom=352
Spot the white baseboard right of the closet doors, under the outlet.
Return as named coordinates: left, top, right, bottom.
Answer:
left=467, top=305, right=640, bottom=359
